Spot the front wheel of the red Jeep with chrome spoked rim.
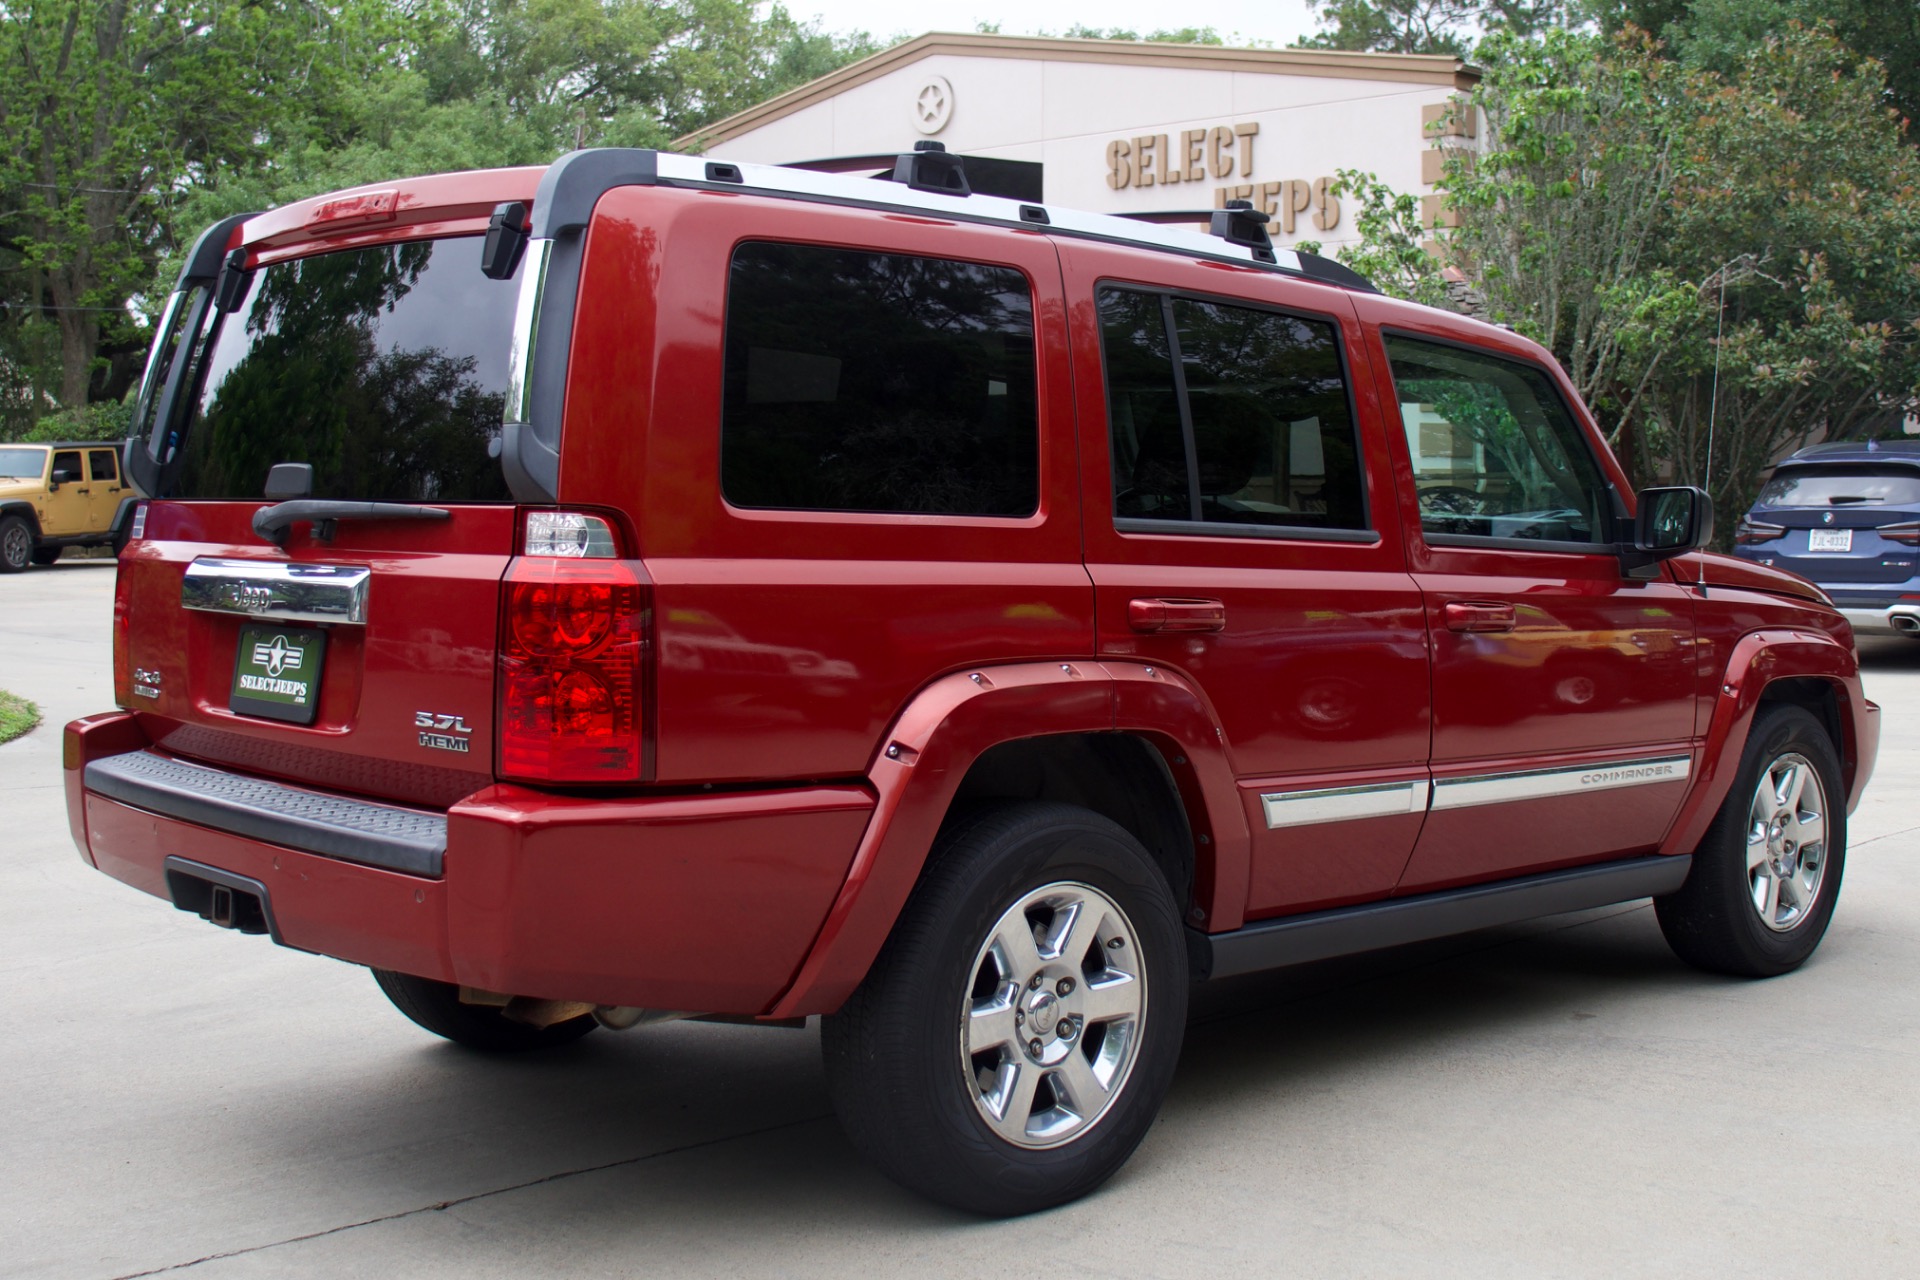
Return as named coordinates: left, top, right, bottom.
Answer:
left=1653, top=704, right=1847, bottom=977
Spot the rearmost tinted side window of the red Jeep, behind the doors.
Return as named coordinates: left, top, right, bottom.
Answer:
left=720, top=244, right=1039, bottom=516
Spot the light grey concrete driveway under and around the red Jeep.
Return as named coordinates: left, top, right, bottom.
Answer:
left=11, top=562, right=1920, bottom=1280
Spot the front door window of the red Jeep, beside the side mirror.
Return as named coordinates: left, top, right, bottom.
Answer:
left=1386, top=336, right=1613, bottom=543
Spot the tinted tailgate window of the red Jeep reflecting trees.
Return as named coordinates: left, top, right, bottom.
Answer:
left=162, top=238, right=518, bottom=503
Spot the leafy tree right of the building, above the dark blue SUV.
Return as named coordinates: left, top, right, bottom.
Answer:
left=1446, top=27, right=1920, bottom=533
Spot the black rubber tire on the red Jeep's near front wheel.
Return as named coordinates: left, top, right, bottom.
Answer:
left=1653, top=702, right=1847, bottom=977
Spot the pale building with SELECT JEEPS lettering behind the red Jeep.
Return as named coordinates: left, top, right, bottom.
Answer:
left=682, top=33, right=1476, bottom=253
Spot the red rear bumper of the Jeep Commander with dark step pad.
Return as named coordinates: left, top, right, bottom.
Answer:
left=63, top=714, right=874, bottom=1015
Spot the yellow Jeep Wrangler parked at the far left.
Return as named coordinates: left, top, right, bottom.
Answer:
left=0, top=443, right=134, bottom=574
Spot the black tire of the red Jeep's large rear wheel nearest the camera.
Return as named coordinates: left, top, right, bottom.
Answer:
left=822, top=802, right=1187, bottom=1215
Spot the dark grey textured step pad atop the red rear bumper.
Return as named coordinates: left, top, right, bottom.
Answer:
left=84, top=750, right=447, bottom=879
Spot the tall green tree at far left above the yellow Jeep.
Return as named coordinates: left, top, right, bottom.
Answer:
left=0, top=0, right=341, bottom=407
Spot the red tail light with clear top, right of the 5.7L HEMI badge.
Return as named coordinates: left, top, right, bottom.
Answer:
left=497, top=512, right=653, bottom=783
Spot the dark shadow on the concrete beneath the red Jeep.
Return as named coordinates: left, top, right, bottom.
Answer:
left=217, top=904, right=1722, bottom=1245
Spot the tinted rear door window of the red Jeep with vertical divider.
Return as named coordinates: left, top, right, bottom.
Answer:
left=1100, top=288, right=1367, bottom=532
